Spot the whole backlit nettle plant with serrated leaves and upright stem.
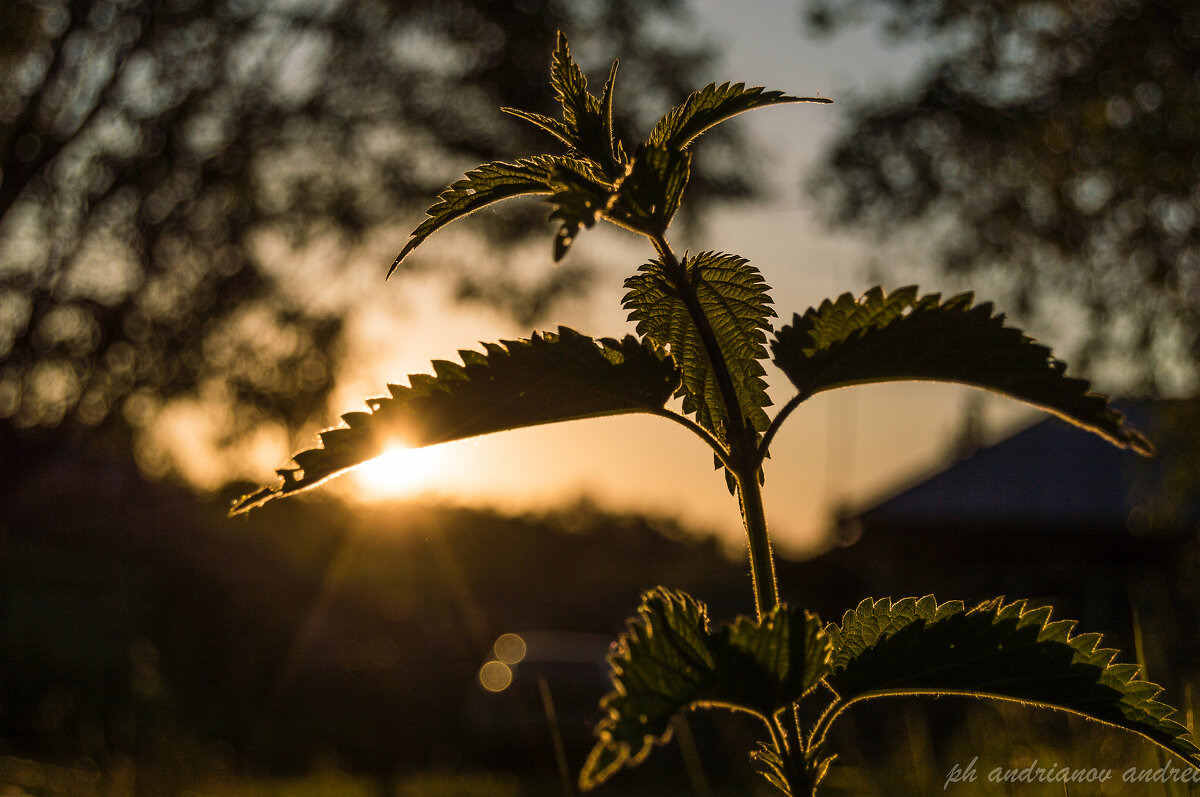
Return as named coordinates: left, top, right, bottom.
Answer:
left=233, top=35, right=1200, bottom=795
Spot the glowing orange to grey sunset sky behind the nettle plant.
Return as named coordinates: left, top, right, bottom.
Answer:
left=234, top=0, right=1031, bottom=555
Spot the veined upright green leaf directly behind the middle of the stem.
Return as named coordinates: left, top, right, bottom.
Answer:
left=624, top=252, right=775, bottom=442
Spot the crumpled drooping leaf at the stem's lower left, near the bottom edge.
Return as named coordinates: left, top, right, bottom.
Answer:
left=580, top=587, right=830, bottom=790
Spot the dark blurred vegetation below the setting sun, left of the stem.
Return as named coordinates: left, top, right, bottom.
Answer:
left=0, top=422, right=777, bottom=795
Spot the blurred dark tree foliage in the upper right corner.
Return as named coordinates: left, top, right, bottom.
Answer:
left=806, top=0, right=1200, bottom=391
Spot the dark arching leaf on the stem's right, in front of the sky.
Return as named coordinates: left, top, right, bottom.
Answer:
left=772, top=287, right=1153, bottom=454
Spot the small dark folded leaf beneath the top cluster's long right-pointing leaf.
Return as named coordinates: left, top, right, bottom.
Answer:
left=607, top=146, right=691, bottom=235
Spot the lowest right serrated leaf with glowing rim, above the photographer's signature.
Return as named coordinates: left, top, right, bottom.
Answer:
left=826, top=595, right=1200, bottom=766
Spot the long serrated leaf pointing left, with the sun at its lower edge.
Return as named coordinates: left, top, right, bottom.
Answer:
left=233, top=326, right=679, bottom=513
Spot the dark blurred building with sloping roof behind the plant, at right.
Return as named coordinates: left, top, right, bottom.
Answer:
left=799, top=401, right=1200, bottom=682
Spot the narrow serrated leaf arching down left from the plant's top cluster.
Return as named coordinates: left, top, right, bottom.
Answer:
left=388, top=155, right=565, bottom=276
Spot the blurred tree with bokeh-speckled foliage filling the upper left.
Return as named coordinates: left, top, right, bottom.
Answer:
left=0, top=0, right=749, bottom=482
